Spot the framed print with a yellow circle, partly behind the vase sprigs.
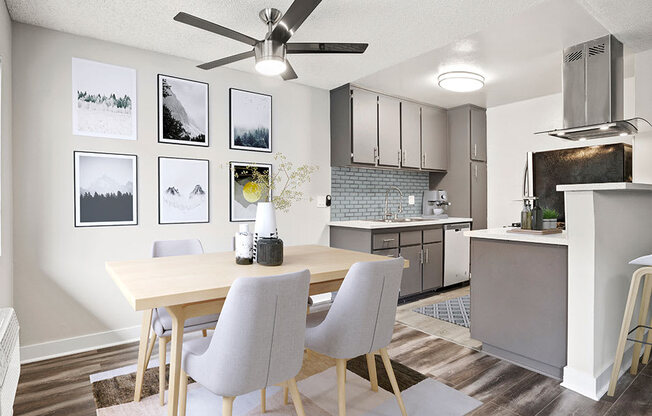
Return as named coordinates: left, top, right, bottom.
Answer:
left=229, top=162, right=272, bottom=222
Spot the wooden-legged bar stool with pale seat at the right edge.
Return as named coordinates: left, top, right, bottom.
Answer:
left=607, top=254, right=652, bottom=396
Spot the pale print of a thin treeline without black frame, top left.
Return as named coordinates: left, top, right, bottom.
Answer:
left=72, top=58, right=138, bottom=140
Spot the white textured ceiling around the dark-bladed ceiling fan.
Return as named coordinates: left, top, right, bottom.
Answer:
left=6, top=0, right=541, bottom=89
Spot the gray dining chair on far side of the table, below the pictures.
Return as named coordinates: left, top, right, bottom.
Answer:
left=137, top=239, right=219, bottom=406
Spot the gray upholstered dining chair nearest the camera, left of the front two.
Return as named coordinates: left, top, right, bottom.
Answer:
left=179, top=270, right=310, bottom=416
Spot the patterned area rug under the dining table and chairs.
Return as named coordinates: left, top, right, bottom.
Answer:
left=91, top=351, right=482, bottom=416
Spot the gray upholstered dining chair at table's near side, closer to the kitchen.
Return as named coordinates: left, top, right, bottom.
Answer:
left=306, top=257, right=407, bottom=416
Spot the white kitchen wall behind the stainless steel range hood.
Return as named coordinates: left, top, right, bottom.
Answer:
left=487, top=78, right=636, bottom=227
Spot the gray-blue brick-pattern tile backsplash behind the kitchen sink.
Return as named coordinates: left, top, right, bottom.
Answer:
left=331, top=167, right=428, bottom=221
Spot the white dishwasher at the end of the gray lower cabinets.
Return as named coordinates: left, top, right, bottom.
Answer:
left=444, top=222, right=471, bottom=287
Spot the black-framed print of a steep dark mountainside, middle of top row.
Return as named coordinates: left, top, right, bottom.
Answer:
left=158, top=74, right=208, bottom=147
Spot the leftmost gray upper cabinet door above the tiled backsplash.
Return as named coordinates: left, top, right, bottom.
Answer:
left=351, top=88, right=378, bottom=165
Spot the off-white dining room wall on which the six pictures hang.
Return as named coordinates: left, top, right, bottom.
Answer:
left=13, top=24, right=330, bottom=359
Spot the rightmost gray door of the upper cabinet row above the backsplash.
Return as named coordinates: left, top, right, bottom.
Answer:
left=421, top=106, right=448, bottom=171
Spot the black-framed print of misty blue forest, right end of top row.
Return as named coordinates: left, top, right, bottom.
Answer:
left=229, top=88, right=272, bottom=153
